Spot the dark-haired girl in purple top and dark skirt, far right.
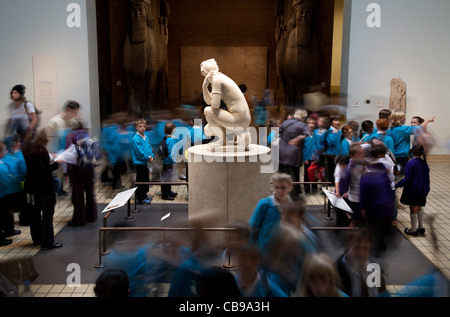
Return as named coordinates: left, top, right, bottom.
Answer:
left=395, top=144, right=430, bottom=236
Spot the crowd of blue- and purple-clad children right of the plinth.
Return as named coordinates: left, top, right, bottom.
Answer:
left=303, top=109, right=434, bottom=236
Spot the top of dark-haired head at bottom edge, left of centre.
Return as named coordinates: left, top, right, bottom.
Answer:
left=94, top=269, right=130, bottom=298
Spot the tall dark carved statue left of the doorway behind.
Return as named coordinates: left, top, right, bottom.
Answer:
left=124, top=0, right=170, bottom=116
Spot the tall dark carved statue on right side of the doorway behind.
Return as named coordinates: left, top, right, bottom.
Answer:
left=275, top=0, right=320, bottom=105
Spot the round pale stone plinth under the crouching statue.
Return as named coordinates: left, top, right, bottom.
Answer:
left=188, top=144, right=272, bottom=228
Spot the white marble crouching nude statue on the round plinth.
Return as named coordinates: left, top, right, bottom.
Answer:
left=200, top=58, right=251, bottom=151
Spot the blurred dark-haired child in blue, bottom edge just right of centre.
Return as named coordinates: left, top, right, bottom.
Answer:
left=235, top=244, right=288, bottom=297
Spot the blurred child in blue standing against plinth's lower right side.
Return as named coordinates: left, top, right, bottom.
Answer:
left=249, top=173, right=292, bottom=254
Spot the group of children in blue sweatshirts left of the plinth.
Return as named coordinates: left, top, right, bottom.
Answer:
left=101, top=115, right=203, bottom=205
